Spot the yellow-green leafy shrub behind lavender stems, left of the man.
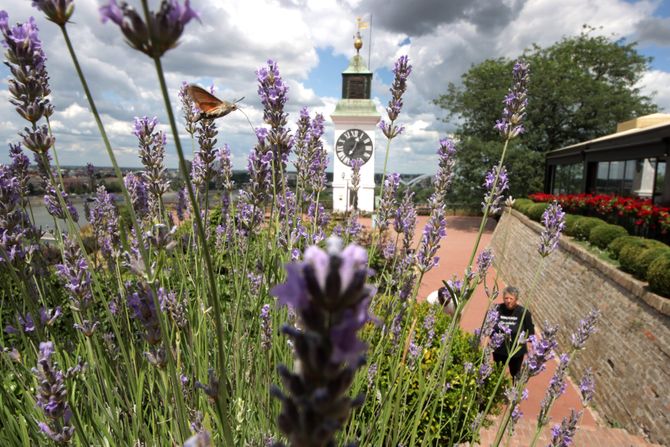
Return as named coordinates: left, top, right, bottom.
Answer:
left=360, top=295, right=510, bottom=445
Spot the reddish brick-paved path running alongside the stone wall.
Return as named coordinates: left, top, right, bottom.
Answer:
left=410, top=216, right=652, bottom=447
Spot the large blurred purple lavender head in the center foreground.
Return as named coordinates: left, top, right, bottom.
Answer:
left=271, top=238, right=375, bottom=446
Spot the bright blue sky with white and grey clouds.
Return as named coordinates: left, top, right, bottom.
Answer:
left=0, top=0, right=670, bottom=174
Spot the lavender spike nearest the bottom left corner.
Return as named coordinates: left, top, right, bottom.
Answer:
left=32, top=341, right=74, bottom=443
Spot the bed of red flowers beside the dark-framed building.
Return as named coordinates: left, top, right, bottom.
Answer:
left=528, top=193, right=670, bottom=239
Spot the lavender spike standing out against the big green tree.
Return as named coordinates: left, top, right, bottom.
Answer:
left=494, top=60, right=529, bottom=140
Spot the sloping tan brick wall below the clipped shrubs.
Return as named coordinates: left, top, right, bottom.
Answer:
left=492, top=210, right=670, bottom=445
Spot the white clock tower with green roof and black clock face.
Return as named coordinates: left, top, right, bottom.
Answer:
left=330, top=31, right=381, bottom=212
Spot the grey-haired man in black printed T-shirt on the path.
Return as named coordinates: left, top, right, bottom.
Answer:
left=493, top=286, right=535, bottom=379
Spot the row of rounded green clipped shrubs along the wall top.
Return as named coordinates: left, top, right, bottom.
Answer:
left=513, top=199, right=670, bottom=297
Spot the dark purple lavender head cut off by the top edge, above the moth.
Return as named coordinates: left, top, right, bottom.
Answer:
left=99, top=0, right=200, bottom=58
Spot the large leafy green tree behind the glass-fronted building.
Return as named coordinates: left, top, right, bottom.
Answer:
left=435, top=27, right=658, bottom=205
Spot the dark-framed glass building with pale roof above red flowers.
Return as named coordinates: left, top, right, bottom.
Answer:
left=544, top=113, right=670, bottom=206
